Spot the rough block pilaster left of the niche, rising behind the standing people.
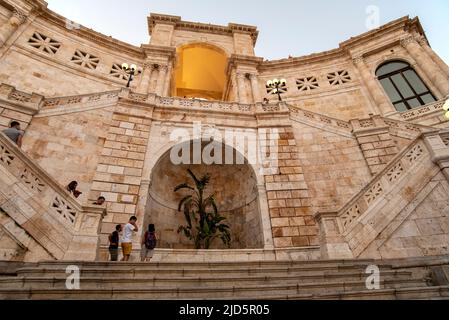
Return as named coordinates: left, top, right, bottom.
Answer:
left=89, top=108, right=151, bottom=245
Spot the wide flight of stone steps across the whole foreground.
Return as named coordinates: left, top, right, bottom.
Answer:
left=0, top=256, right=449, bottom=300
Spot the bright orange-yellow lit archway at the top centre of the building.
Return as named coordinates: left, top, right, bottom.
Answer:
left=172, top=43, right=228, bottom=100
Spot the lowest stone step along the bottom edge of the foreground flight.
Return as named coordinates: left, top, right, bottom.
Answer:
left=0, top=281, right=434, bottom=300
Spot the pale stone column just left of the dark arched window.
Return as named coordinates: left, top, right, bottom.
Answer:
left=352, top=56, right=392, bottom=115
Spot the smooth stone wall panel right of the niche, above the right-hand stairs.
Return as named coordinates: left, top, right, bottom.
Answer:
left=293, top=121, right=371, bottom=212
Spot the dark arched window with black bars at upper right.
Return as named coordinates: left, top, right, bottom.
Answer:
left=376, top=61, right=436, bottom=112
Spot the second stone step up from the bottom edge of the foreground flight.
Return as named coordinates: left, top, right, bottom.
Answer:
left=0, top=271, right=416, bottom=289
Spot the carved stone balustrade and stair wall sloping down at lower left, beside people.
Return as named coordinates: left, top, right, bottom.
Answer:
left=0, top=133, right=105, bottom=260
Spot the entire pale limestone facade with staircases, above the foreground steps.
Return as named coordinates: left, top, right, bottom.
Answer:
left=0, top=0, right=449, bottom=261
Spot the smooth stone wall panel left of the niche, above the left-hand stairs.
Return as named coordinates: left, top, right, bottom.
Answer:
left=22, top=107, right=112, bottom=202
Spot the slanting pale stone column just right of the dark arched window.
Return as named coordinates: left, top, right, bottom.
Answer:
left=401, top=36, right=449, bottom=97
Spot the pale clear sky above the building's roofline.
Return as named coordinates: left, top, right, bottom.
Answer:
left=46, top=0, right=449, bottom=63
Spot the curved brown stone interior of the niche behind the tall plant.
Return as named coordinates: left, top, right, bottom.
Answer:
left=144, top=141, right=264, bottom=249
